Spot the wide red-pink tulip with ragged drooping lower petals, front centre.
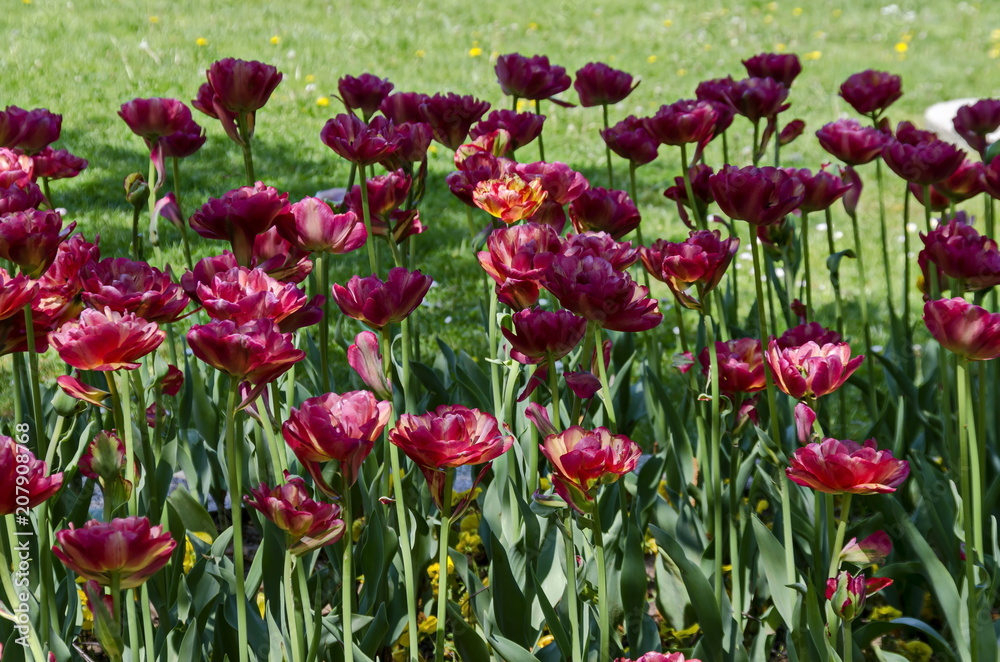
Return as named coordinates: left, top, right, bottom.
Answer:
left=389, top=405, right=514, bottom=510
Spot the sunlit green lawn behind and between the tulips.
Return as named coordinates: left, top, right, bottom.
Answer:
left=0, top=0, right=1000, bottom=414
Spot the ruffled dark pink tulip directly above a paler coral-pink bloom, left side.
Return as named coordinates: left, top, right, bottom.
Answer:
left=80, top=257, right=189, bottom=323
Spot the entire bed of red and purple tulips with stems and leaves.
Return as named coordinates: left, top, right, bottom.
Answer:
left=0, top=45, right=1000, bottom=662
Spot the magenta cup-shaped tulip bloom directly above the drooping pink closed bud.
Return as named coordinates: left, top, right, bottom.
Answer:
left=333, top=267, right=433, bottom=331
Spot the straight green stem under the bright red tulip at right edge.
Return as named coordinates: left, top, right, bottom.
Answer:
left=956, top=360, right=981, bottom=655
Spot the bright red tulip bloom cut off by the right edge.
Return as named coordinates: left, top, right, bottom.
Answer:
left=924, top=297, right=1000, bottom=361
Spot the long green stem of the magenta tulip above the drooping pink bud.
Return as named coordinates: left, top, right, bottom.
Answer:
left=380, top=330, right=419, bottom=662
